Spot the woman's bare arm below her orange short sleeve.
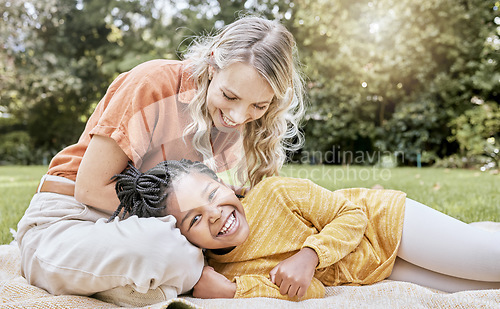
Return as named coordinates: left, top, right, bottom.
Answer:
left=75, top=135, right=129, bottom=214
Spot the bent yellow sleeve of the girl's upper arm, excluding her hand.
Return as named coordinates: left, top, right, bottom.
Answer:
left=259, top=177, right=368, bottom=269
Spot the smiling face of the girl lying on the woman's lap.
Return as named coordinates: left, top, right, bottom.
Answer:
left=167, top=173, right=249, bottom=249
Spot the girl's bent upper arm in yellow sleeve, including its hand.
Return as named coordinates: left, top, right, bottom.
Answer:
left=262, top=179, right=367, bottom=297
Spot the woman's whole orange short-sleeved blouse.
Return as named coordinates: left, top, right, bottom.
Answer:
left=48, top=60, right=241, bottom=180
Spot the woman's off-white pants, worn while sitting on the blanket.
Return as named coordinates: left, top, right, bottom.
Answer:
left=17, top=175, right=204, bottom=297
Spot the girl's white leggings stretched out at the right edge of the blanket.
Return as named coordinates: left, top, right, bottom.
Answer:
left=388, top=199, right=500, bottom=292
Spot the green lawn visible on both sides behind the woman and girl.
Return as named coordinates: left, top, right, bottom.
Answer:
left=0, top=165, right=500, bottom=244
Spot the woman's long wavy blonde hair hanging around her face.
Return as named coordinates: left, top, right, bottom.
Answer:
left=185, top=16, right=305, bottom=186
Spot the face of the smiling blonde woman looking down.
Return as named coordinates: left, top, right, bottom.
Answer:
left=207, top=62, right=274, bottom=132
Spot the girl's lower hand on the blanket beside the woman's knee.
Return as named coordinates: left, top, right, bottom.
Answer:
left=193, top=266, right=236, bottom=298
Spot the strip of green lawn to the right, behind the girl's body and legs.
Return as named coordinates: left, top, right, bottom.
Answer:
left=282, top=165, right=500, bottom=223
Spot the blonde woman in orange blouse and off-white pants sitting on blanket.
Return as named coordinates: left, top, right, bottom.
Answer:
left=17, top=17, right=304, bottom=300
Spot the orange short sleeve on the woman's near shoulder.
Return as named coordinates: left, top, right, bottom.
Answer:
left=88, top=60, right=188, bottom=166
